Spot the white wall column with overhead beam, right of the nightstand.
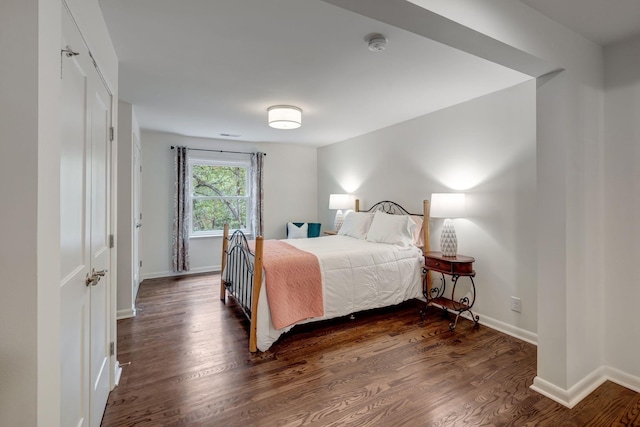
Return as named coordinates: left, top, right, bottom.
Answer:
left=324, top=0, right=608, bottom=406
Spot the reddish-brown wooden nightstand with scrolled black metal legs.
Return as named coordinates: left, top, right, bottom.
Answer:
left=420, top=252, right=480, bottom=331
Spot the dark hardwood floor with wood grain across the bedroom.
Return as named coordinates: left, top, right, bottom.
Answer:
left=102, top=275, right=640, bottom=427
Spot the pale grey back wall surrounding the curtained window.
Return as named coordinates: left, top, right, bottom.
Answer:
left=140, top=130, right=318, bottom=279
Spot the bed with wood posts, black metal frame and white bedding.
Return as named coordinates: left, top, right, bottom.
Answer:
left=220, top=200, right=429, bottom=352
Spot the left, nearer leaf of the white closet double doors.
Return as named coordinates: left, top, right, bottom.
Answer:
left=60, top=7, right=91, bottom=427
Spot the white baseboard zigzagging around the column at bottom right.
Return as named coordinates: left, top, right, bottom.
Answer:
left=531, top=366, right=640, bottom=409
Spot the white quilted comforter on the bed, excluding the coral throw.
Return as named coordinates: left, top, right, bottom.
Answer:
left=257, top=236, right=424, bottom=351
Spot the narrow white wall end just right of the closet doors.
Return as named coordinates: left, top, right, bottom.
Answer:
left=115, top=101, right=140, bottom=319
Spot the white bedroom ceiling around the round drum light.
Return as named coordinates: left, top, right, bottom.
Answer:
left=99, top=0, right=640, bottom=146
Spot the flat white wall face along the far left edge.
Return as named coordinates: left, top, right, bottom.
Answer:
left=0, top=0, right=45, bottom=426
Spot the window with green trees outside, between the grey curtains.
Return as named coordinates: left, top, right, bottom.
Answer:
left=189, top=159, right=251, bottom=237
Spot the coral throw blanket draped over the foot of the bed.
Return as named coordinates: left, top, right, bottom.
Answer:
left=252, top=240, right=324, bottom=329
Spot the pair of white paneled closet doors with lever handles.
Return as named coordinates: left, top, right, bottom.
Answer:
left=60, top=7, right=113, bottom=427
